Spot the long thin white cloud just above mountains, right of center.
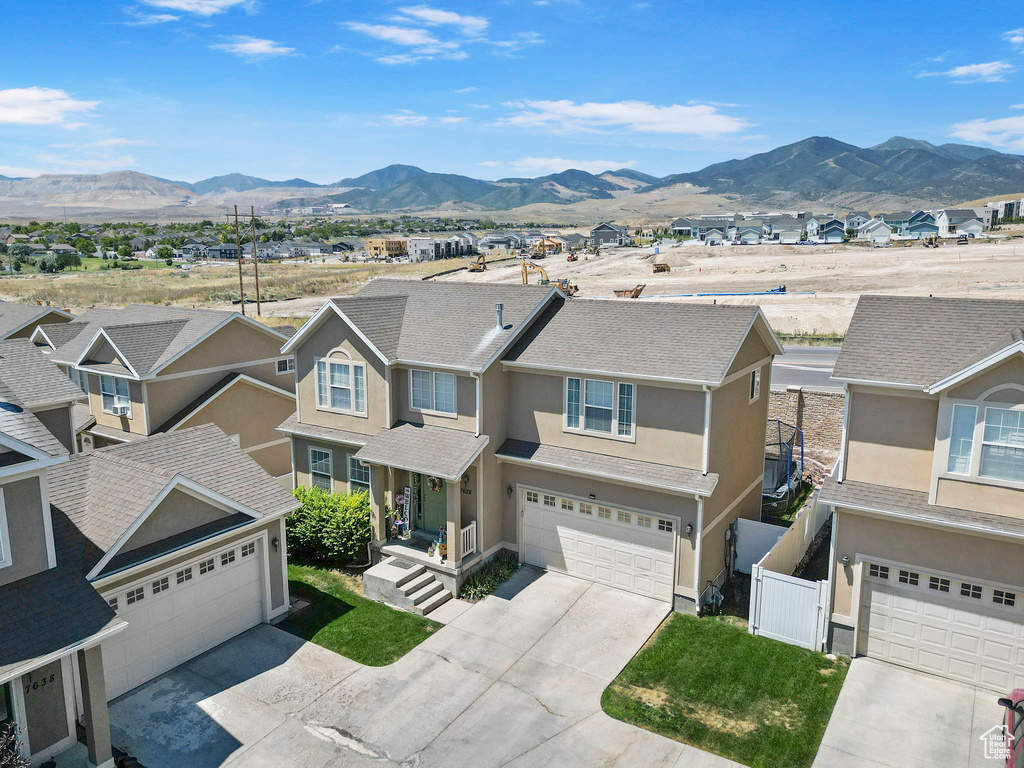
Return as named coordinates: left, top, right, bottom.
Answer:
left=497, top=99, right=751, bottom=136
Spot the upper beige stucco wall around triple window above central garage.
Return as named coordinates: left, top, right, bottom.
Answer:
left=501, top=371, right=703, bottom=469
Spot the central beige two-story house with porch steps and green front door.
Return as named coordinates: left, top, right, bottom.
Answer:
left=281, top=280, right=779, bottom=612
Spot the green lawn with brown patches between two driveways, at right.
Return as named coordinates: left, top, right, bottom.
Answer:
left=601, top=613, right=847, bottom=768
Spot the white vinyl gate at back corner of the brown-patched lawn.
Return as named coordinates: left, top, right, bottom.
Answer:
left=749, top=565, right=828, bottom=650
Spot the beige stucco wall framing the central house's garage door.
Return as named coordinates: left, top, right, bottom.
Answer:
left=501, top=463, right=697, bottom=588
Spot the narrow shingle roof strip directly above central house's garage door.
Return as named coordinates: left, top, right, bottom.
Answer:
left=497, top=438, right=718, bottom=496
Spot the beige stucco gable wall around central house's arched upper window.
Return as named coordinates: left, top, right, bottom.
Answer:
left=295, top=315, right=391, bottom=434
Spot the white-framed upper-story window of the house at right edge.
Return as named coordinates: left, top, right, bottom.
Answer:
left=946, top=403, right=1024, bottom=482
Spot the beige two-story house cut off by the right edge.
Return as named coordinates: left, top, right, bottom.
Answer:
left=819, top=296, right=1024, bottom=693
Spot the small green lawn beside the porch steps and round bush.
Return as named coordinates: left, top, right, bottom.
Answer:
left=278, top=564, right=441, bottom=667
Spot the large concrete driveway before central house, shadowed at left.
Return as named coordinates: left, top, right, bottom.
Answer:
left=111, top=567, right=736, bottom=768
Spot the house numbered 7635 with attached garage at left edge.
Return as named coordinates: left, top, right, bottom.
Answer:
left=0, top=341, right=297, bottom=768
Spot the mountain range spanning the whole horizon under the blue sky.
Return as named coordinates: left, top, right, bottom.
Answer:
left=0, top=136, right=1024, bottom=216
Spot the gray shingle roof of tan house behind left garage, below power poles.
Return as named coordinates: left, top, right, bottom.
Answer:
left=43, top=304, right=288, bottom=376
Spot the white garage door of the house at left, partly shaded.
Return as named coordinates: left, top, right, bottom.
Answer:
left=103, top=541, right=266, bottom=698
